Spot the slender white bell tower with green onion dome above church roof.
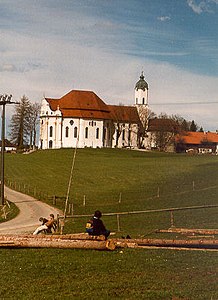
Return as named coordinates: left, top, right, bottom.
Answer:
left=135, top=71, right=148, bottom=106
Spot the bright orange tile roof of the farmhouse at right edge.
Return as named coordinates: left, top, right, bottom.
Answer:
left=178, top=132, right=218, bottom=145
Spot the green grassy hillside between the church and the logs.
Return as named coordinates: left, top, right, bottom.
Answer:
left=5, top=149, right=218, bottom=235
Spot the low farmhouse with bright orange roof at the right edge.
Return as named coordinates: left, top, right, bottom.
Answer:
left=176, top=132, right=218, bottom=154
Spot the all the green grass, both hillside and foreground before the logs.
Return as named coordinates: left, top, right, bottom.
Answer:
left=0, top=149, right=218, bottom=300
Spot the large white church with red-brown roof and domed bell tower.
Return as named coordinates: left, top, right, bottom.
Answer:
left=39, top=72, right=148, bottom=149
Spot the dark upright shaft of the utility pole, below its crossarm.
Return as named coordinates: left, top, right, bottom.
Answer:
left=1, top=103, right=6, bottom=205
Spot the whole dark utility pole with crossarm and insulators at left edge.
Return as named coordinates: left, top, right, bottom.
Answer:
left=0, top=94, right=17, bottom=205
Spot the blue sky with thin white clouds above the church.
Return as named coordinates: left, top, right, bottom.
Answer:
left=0, top=0, right=218, bottom=131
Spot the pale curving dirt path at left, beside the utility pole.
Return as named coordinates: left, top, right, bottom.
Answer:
left=0, top=187, right=61, bottom=234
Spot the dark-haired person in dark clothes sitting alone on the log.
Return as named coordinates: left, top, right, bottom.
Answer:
left=86, top=210, right=110, bottom=239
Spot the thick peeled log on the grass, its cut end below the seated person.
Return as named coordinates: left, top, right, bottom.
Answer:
left=0, top=235, right=115, bottom=250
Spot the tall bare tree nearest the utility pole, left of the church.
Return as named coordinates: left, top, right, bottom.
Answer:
left=9, top=95, right=31, bottom=149
